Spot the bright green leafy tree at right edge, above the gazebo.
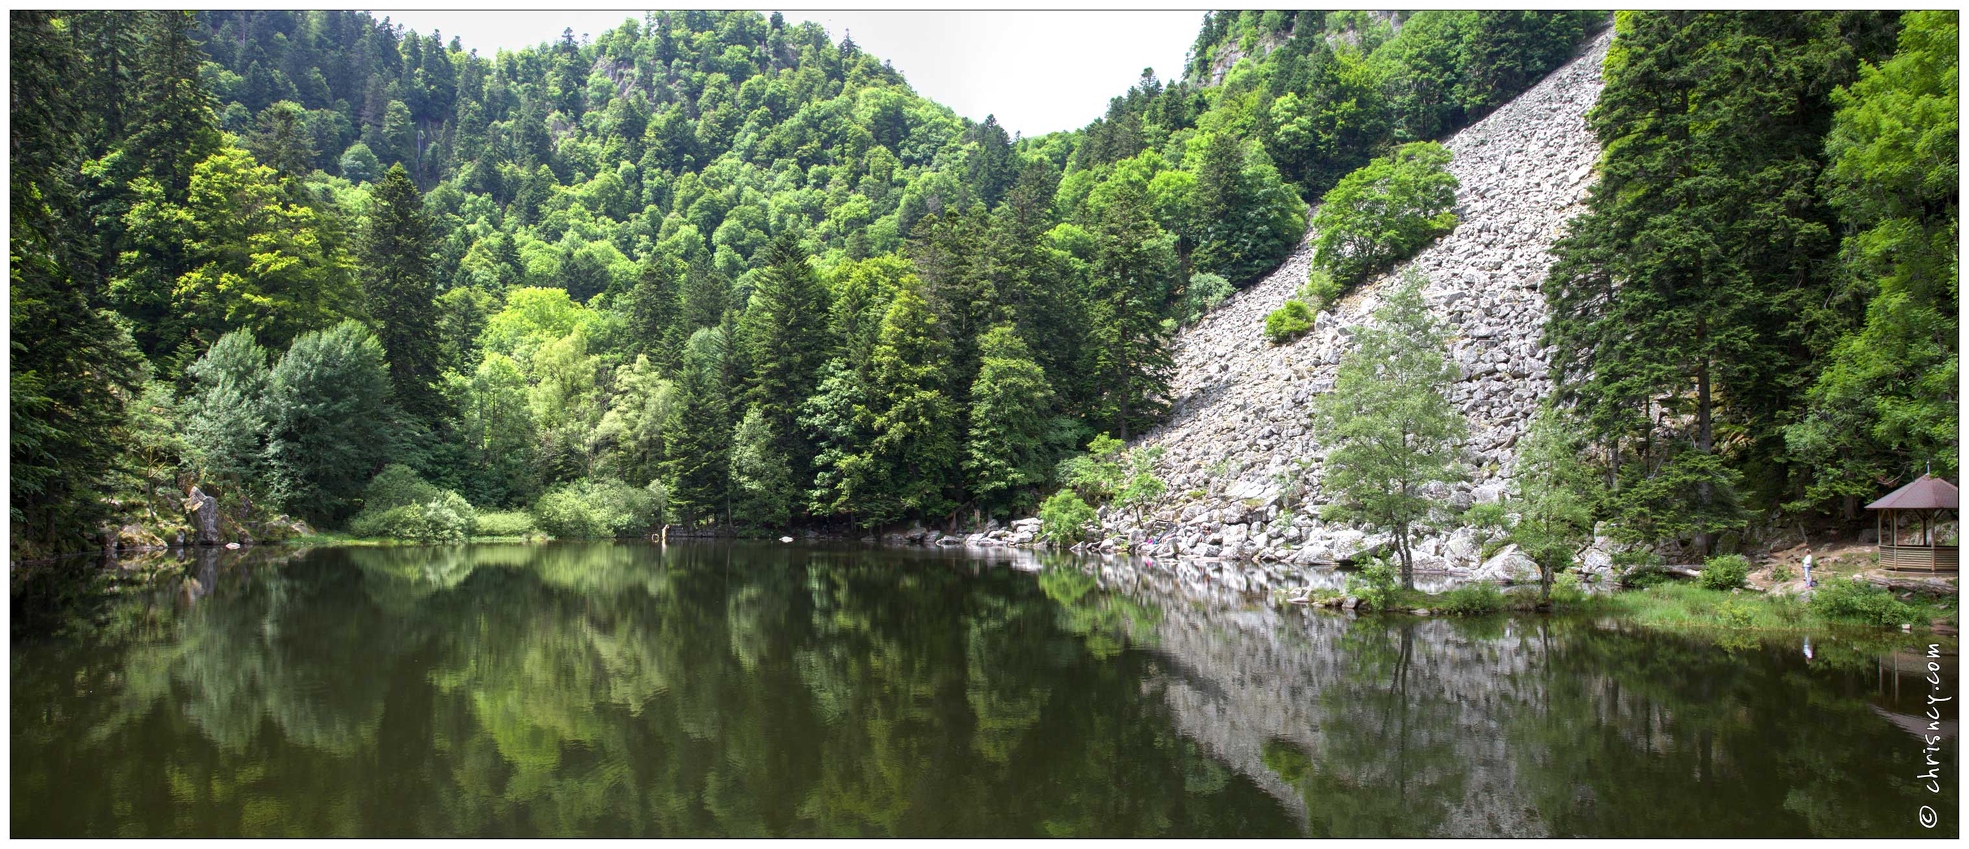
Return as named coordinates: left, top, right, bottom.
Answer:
left=1784, top=12, right=1961, bottom=518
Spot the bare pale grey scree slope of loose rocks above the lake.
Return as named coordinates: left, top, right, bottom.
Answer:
left=1105, top=30, right=1613, bottom=581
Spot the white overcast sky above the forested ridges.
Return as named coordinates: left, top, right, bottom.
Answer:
left=374, top=10, right=1203, bottom=136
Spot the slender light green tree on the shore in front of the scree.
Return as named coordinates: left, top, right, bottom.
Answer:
left=1313, top=274, right=1469, bottom=589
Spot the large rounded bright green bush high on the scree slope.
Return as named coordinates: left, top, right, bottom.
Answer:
left=1313, top=142, right=1459, bottom=290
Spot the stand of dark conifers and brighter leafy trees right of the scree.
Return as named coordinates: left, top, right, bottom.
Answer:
left=1546, top=12, right=1959, bottom=548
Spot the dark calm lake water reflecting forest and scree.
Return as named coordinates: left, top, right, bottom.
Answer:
left=10, top=544, right=1959, bottom=837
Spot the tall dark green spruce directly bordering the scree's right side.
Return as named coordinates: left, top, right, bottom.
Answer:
left=1546, top=12, right=1892, bottom=554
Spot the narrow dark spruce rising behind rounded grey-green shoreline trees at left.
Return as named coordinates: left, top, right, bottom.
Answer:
left=362, top=165, right=443, bottom=422
